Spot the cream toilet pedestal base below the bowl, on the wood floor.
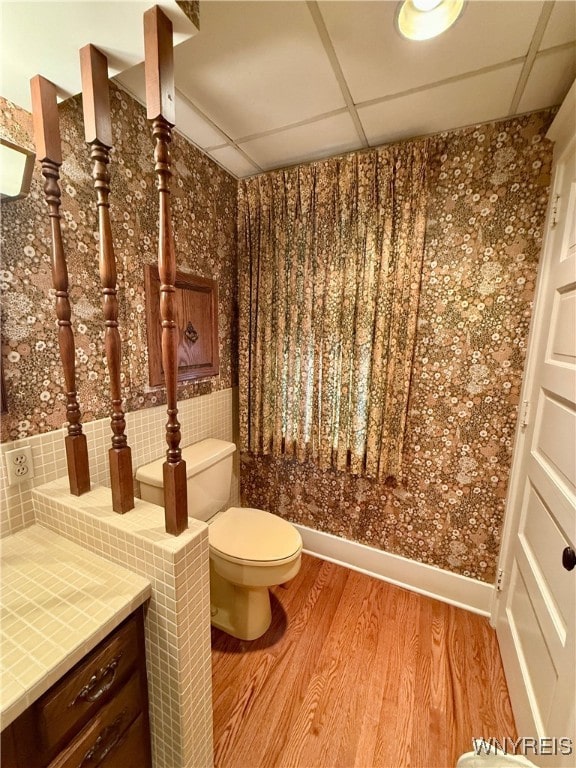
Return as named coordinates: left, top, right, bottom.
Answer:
left=210, top=559, right=272, bottom=640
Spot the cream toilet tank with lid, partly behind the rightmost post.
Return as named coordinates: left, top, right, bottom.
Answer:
left=136, top=437, right=236, bottom=520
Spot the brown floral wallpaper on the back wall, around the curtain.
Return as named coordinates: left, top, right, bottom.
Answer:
left=241, top=112, right=553, bottom=582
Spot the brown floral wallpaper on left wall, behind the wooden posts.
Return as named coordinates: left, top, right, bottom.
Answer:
left=0, top=84, right=237, bottom=441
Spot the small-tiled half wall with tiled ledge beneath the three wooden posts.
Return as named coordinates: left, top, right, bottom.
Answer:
left=33, top=478, right=212, bottom=768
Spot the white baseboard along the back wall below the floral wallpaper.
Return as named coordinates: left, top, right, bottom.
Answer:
left=295, top=525, right=494, bottom=616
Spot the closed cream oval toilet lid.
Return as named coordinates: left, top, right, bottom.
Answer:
left=208, top=507, right=302, bottom=562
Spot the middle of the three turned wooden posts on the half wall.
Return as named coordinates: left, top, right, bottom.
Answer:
left=80, top=45, right=134, bottom=514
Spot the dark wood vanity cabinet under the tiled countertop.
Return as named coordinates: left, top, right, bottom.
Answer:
left=2, top=608, right=151, bottom=768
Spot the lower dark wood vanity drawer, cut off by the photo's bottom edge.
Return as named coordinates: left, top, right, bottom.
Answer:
left=49, top=672, right=142, bottom=768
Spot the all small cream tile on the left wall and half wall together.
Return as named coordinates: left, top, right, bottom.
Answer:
left=0, top=389, right=240, bottom=768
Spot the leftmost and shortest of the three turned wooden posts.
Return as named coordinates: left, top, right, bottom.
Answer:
left=30, top=75, right=90, bottom=496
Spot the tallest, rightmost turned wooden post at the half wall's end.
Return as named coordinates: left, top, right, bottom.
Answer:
left=144, top=6, right=188, bottom=535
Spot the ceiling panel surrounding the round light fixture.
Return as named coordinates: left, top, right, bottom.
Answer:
left=319, top=0, right=542, bottom=104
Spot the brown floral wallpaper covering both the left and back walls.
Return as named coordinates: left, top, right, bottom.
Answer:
left=0, top=85, right=553, bottom=582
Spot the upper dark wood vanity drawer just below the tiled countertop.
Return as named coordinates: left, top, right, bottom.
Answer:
left=35, top=616, right=139, bottom=759
